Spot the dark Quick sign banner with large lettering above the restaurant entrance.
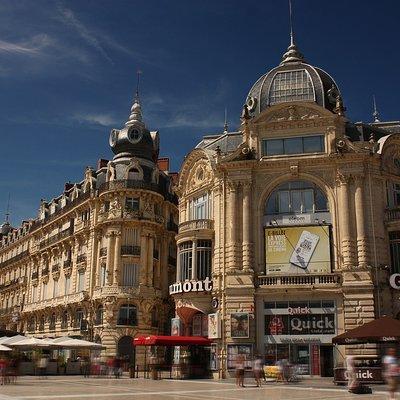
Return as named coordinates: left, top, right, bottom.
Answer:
left=265, top=314, right=336, bottom=336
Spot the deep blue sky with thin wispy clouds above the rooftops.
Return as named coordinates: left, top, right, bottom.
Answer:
left=0, top=0, right=400, bottom=225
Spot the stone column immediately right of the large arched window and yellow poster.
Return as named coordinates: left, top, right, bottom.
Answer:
left=337, top=173, right=354, bottom=269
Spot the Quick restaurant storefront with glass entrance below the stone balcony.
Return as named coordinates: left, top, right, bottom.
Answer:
left=263, top=300, right=337, bottom=376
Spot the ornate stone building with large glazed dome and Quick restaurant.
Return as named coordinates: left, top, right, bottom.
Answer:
left=170, top=38, right=400, bottom=377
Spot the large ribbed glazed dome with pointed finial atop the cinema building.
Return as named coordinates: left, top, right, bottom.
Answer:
left=246, top=40, right=344, bottom=116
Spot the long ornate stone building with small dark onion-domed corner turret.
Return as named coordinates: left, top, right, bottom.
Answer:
left=0, top=92, right=178, bottom=357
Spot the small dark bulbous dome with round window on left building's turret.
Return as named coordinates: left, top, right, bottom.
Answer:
left=110, top=96, right=159, bottom=161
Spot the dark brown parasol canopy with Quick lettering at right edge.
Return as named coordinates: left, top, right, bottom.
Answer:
left=332, top=317, right=400, bottom=344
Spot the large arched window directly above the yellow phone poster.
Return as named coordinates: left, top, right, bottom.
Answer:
left=265, top=181, right=328, bottom=215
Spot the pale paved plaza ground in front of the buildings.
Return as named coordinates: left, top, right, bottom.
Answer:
left=0, top=376, right=400, bottom=400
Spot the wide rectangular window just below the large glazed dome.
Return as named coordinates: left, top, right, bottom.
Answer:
left=262, top=135, right=325, bottom=156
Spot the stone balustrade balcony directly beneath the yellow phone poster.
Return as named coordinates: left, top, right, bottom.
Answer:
left=257, top=274, right=341, bottom=289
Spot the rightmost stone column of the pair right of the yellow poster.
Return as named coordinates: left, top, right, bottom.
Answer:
left=354, top=176, right=368, bottom=267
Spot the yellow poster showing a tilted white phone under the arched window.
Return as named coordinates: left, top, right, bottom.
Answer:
left=265, top=225, right=331, bottom=274
